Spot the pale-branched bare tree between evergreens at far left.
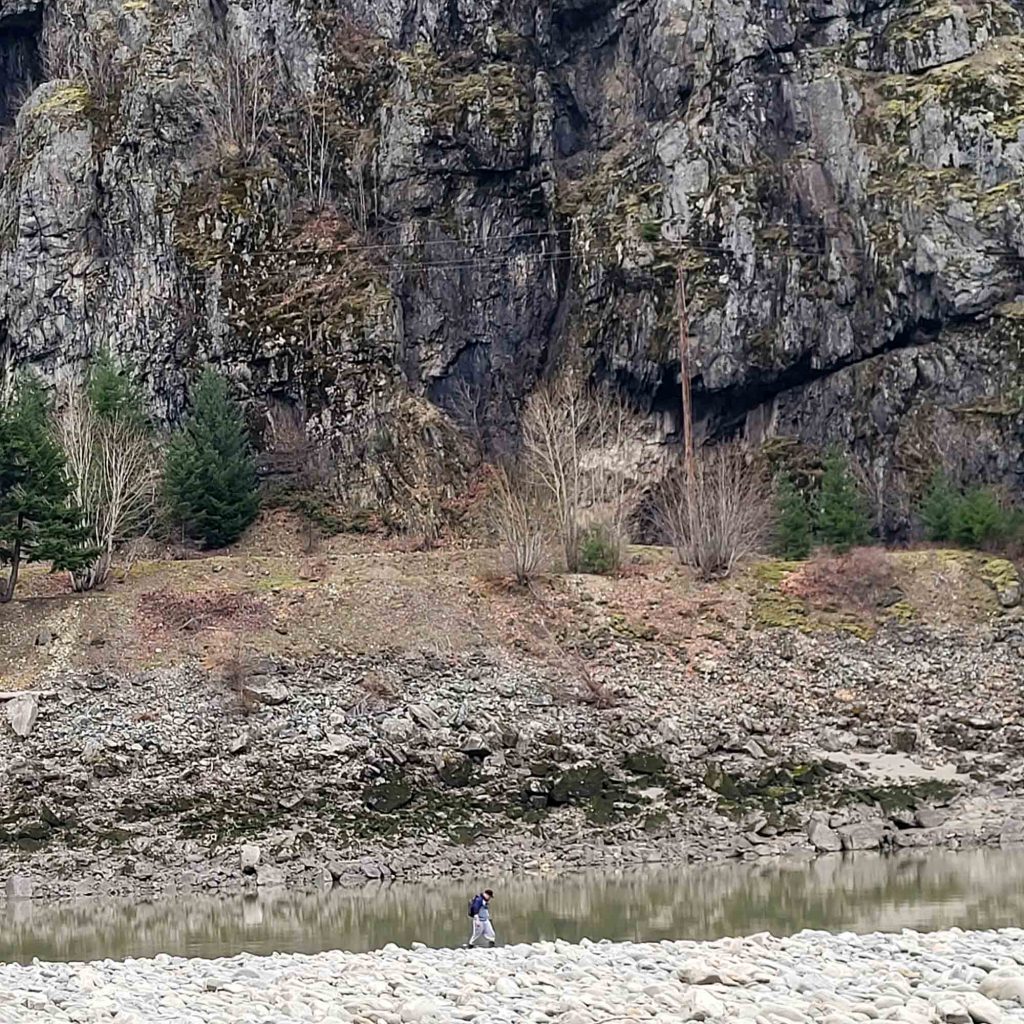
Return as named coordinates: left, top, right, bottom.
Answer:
left=58, top=388, right=160, bottom=591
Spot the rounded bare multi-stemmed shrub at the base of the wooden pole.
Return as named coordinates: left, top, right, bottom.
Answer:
left=654, top=443, right=772, bottom=579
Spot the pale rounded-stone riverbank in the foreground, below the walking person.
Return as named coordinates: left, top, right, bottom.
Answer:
left=6, top=929, right=1024, bottom=1024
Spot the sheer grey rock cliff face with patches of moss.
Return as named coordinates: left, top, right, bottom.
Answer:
left=0, top=0, right=1024, bottom=525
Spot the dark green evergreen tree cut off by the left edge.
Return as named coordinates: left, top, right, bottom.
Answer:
left=0, top=378, right=96, bottom=603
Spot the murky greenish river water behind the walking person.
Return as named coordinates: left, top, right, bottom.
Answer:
left=0, top=849, right=1024, bottom=963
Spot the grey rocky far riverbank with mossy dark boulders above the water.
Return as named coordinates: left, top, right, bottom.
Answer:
left=0, top=622, right=1024, bottom=896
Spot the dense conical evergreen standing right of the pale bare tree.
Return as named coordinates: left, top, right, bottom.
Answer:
left=165, top=370, right=259, bottom=548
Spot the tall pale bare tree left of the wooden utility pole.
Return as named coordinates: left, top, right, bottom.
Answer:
left=522, top=373, right=639, bottom=571
